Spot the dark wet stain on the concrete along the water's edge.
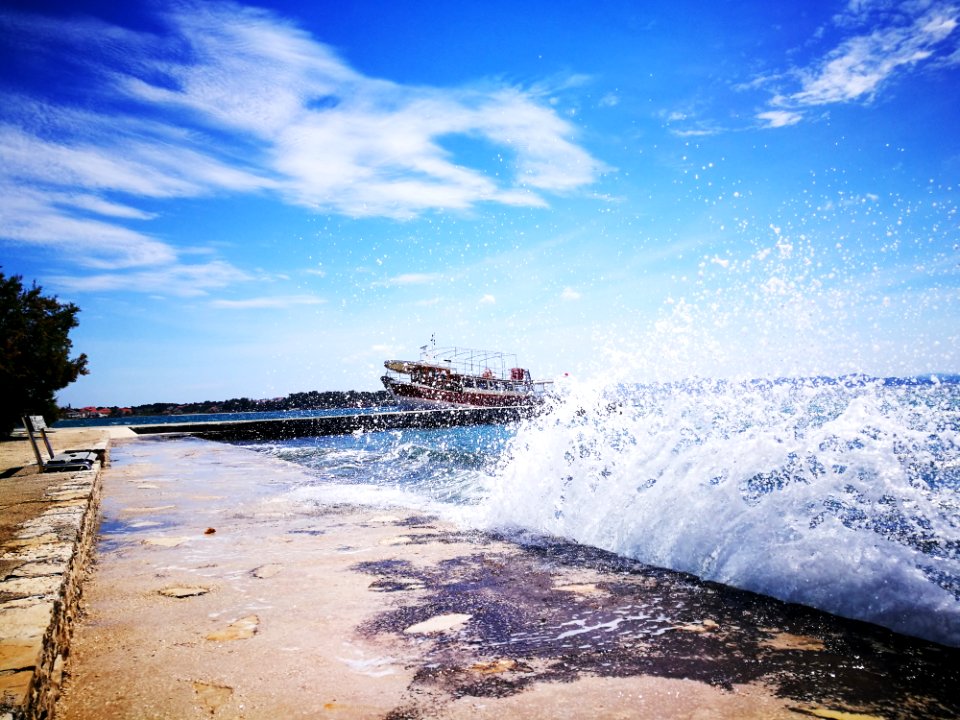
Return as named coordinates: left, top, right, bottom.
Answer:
left=354, top=538, right=960, bottom=718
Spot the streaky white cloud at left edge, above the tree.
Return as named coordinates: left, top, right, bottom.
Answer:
left=0, top=114, right=269, bottom=269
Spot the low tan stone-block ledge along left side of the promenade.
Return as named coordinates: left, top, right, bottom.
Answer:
left=0, top=456, right=103, bottom=720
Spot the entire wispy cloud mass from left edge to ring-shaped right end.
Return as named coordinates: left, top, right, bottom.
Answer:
left=0, top=2, right=604, bottom=291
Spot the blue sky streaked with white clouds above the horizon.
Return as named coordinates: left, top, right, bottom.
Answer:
left=0, top=0, right=960, bottom=405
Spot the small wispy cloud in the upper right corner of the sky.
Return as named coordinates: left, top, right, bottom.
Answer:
left=756, top=2, right=960, bottom=128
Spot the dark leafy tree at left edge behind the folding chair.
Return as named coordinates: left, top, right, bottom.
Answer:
left=0, top=272, right=87, bottom=435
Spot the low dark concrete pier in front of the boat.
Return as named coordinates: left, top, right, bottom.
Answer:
left=131, top=407, right=541, bottom=440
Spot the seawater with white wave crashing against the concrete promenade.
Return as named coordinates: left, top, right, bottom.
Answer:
left=244, top=376, right=960, bottom=646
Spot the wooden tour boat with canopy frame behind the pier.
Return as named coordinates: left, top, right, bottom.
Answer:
left=380, top=343, right=553, bottom=407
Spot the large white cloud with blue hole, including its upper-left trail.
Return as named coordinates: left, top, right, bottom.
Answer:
left=120, top=4, right=602, bottom=218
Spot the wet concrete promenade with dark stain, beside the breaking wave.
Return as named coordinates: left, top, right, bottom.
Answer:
left=57, top=438, right=960, bottom=720
